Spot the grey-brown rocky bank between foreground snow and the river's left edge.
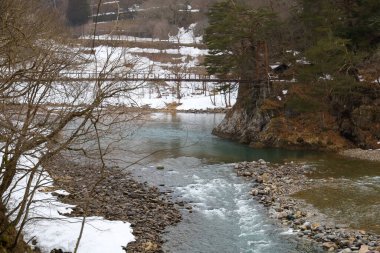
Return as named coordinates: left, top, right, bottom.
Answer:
left=44, top=156, right=183, bottom=253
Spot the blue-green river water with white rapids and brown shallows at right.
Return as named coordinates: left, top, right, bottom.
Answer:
left=110, top=113, right=380, bottom=253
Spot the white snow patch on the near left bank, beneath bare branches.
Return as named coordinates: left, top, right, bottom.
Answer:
left=0, top=153, right=134, bottom=253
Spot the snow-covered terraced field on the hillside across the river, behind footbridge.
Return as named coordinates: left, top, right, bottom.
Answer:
left=75, top=24, right=237, bottom=110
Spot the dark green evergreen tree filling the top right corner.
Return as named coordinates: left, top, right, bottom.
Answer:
left=300, top=0, right=380, bottom=83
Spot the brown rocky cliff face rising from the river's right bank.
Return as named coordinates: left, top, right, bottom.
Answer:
left=213, top=84, right=380, bottom=150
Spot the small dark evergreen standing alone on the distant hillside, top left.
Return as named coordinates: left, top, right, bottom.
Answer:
left=66, top=0, right=91, bottom=26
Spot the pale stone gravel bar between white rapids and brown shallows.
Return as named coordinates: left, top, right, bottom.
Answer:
left=235, top=160, right=380, bottom=253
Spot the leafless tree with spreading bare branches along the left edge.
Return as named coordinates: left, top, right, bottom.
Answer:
left=0, top=0, right=145, bottom=251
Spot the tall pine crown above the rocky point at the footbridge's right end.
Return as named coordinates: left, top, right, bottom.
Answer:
left=204, top=0, right=276, bottom=79
